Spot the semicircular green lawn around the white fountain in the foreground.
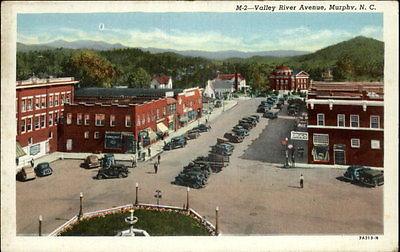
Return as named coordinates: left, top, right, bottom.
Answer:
left=61, top=209, right=210, bottom=236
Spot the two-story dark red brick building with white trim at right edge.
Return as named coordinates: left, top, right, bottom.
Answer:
left=307, top=82, right=384, bottom=167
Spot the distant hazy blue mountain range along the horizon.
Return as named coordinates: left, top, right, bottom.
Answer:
left=17, top=40, right=310, bottom=60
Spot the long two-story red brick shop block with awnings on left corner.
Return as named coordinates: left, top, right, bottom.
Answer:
left=60, top=88, right=202, bottom=153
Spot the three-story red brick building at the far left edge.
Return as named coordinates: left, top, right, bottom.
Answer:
left=15, top=77, right=78, bottom=167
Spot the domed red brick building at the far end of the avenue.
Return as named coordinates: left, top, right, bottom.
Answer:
left=269, top=65, right=310, bottom=93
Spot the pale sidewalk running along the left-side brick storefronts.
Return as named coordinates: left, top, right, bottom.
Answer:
left=35, top=100, right=238, bottom=164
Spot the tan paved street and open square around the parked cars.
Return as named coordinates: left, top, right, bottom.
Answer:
left=16, top=99, right=383, bottom=234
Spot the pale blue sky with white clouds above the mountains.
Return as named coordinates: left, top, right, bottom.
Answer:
left=17, top=12, right=383, bottom=51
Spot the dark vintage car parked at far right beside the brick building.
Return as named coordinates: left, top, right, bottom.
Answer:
left=343, top=166, right=384, bottom=187
